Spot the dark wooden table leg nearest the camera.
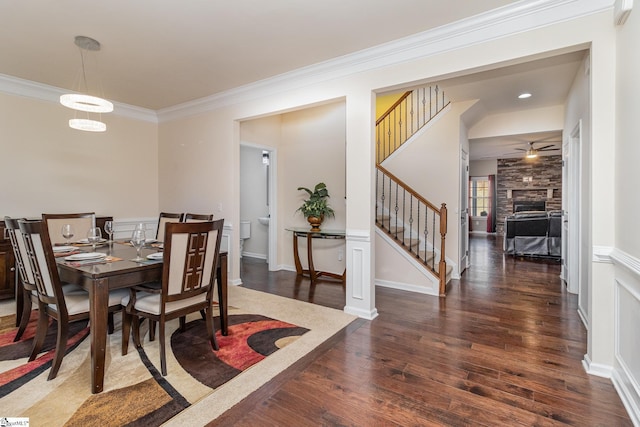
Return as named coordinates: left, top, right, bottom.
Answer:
left=89, top=279, right=109, bottom=393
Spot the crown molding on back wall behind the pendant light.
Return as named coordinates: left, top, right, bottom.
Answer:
left=0, top=74, right=158, bottom=123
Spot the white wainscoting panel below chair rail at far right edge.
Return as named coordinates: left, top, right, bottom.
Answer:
left=611, top=249, right=640, bottom=425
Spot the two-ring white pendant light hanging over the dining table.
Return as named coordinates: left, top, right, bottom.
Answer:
left=60, top=36, right=113, bottom=132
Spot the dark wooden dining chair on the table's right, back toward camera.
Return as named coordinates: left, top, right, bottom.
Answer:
left=122, top=219, right=224, bottom=376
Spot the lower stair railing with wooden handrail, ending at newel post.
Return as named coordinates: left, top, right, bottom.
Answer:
left=376, top=165, right=447, bottom=295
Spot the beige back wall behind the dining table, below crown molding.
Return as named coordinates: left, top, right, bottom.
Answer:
left=0, top=92, right=159, bottom=220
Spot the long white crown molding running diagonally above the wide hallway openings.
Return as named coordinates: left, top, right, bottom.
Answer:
left=158, top=0, right=614, bottom=122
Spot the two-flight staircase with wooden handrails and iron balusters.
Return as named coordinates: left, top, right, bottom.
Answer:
left=376, top=86, right=452, bottom=296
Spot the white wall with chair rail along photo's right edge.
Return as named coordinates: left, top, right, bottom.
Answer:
left=612, top=5, right=640, bottom=425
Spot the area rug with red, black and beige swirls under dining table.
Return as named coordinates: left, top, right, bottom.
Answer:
left=0, top=287, right=355, bottom=426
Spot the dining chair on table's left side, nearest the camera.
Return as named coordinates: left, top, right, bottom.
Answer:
left=18, top=220, right=128, bottom=381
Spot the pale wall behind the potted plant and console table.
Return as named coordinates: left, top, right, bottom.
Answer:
left=278, top=102, right=346, bottom=274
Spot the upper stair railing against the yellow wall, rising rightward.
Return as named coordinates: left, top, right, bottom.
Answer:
left=376, top=85, right=449, bottom=163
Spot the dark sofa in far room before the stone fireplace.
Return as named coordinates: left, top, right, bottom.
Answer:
left=504, top=211, right=562, bottom=258
